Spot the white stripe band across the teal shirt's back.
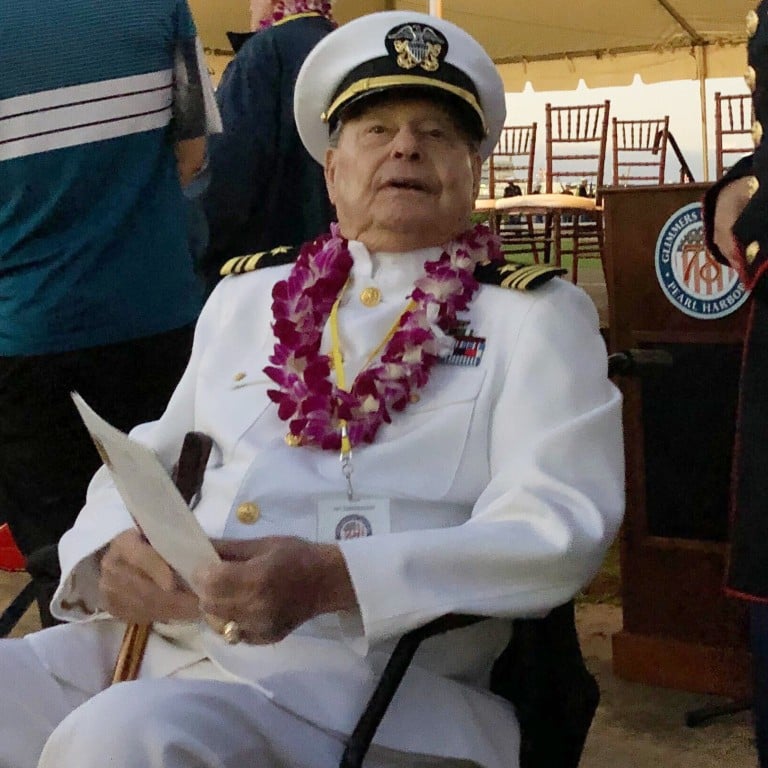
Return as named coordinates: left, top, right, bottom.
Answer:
left=0, top=69, right=173, bottom=161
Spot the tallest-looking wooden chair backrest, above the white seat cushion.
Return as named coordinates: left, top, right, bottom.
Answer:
left=545, top=100, right=611, bottom=192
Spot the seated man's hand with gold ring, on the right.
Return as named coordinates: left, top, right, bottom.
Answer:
left=195, top=536, right=357, bottom=644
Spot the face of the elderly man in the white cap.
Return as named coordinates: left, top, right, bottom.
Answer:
left=325, top=98, right=482, bottom=252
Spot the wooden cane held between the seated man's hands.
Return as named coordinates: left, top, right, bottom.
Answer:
left=112, top=432, right=213, bottom=684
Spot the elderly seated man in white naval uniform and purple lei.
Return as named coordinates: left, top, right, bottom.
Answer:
left=0, top=12, right=623, bottom=768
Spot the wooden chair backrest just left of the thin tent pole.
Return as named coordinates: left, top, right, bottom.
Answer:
left=612, top=115, right=669, bottom=187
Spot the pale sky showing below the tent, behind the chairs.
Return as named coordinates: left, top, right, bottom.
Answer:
left=507, top=76, right=749, bottom=188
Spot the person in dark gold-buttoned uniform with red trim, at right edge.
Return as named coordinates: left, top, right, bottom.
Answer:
left=704, top=0, right=768, bottom=768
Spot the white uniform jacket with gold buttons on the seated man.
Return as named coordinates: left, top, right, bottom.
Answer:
left=31, top=243, right=624, bottom=767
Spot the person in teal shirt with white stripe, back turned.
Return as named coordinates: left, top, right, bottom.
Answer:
left=0, top=0, right=218, bottom=624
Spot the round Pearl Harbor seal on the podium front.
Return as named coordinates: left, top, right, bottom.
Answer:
left=654, top=203, right=749, bottom=320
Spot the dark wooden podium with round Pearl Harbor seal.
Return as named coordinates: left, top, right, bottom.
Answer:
left=603, top=184, right=750, bottom=697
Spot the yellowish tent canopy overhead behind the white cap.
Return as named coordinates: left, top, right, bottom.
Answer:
left=191, top=0, right=755, bottom=91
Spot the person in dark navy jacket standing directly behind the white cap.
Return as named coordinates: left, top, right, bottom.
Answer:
left=199, top=0, right=335, bottom=289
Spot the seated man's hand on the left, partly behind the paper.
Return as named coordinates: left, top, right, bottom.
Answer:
left=99, top=530, right=200, bottom=624
